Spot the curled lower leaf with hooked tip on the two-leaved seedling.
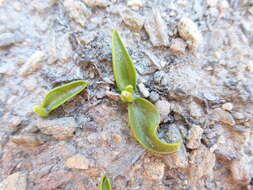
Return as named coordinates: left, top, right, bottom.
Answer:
left=128, top=98, right=181, bottom=153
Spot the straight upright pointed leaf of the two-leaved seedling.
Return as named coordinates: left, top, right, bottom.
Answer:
left=112, top=30, right=136, bottom=91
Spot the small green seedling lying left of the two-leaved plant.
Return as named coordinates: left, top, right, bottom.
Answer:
left=33, top=80, right=88, bottom=117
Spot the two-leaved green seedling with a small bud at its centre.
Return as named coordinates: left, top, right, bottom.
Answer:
left=112, top=30, right=181, bottom=153
